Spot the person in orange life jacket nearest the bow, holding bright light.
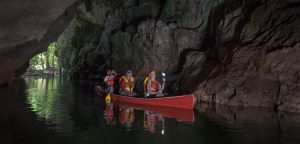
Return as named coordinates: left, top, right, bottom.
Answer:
left=144, top=71, right=166, bottom=98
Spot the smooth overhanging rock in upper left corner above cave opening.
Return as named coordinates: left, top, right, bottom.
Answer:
left=0, top=0, right=79, bottom=84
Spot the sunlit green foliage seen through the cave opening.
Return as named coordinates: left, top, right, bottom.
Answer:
left=30, top=42, right=58, bottom=70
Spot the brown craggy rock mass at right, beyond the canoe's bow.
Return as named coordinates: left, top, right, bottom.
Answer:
left=194, top=1, right=300, bottom=111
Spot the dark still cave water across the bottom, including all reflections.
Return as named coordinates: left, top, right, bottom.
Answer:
left=0, top=77, right=300, bottom=144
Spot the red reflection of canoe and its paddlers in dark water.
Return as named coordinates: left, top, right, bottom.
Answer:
left=104, top=103, right=195, bottom=134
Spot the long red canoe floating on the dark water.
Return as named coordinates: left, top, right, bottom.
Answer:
left=111, top=94, right=195, bottom=109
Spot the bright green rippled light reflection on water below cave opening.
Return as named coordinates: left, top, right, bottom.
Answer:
left=26, top=78, right=73, bottom=132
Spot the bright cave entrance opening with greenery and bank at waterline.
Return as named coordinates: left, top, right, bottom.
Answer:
left=24, top=42, right=59, bottom=77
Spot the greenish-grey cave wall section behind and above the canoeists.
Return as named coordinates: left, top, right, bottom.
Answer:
left=58, top=0, right=225, bottom=82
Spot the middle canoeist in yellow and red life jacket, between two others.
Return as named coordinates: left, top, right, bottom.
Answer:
left=119, top=70, right=136, bottom=96
